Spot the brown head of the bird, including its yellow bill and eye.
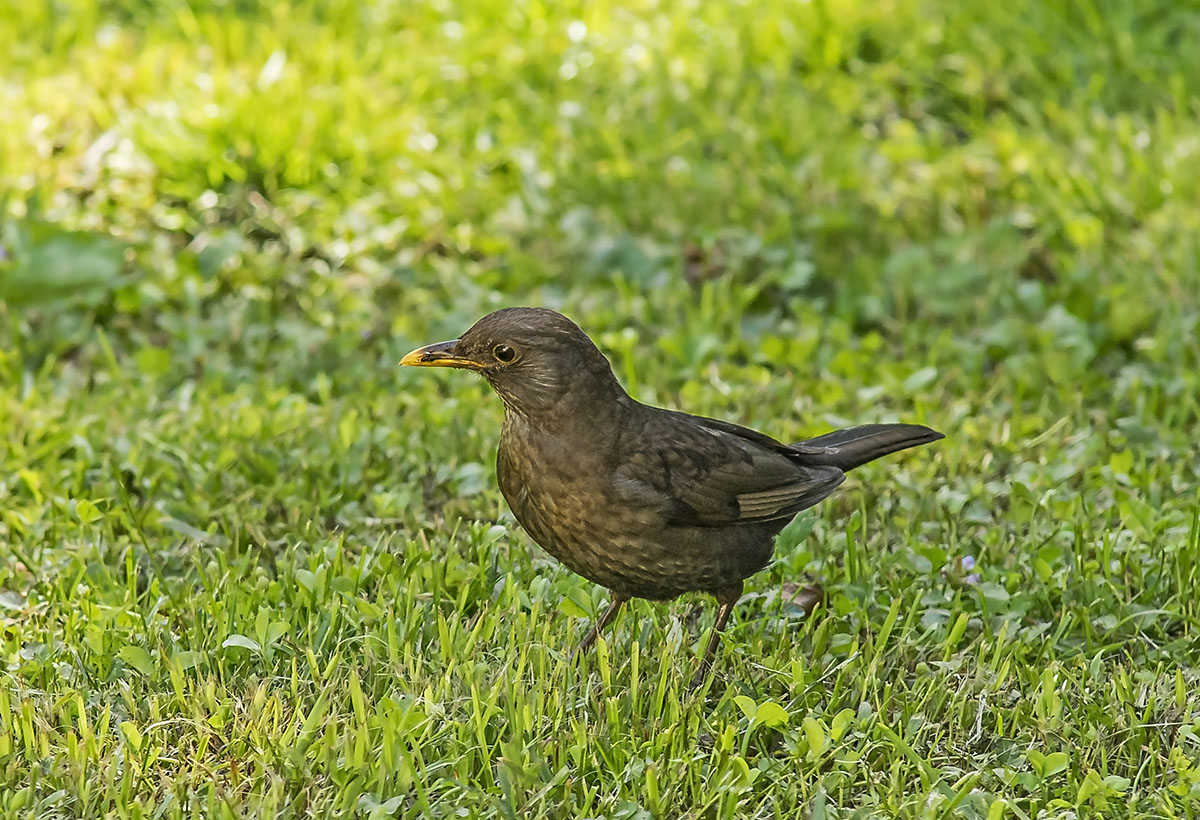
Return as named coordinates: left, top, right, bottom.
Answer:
left=400, top=307, right=625, bottom=417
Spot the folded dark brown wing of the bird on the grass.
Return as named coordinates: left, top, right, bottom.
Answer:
left=614, top=411, right=846, bottom=527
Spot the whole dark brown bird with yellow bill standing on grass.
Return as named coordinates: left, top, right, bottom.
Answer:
left=400, top=307, right=943, bottom=688
